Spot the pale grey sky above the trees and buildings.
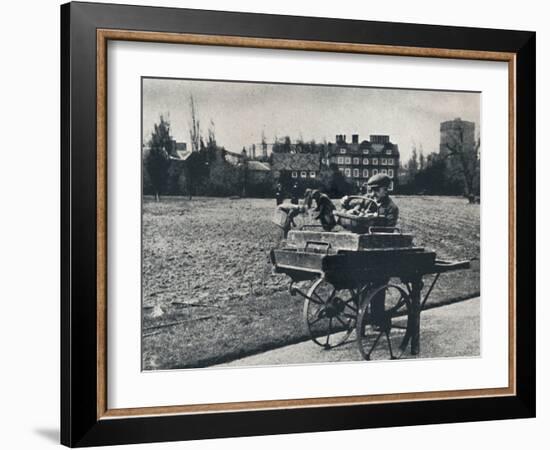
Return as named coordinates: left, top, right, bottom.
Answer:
left=142, top=78, right=480, bottom=162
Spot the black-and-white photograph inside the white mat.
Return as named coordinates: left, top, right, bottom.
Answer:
left=141, top=77, right=482, bottom=371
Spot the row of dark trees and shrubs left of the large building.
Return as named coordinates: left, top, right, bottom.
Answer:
left=143, top=116, right=357, bottom=201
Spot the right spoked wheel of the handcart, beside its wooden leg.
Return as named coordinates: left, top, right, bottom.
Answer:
left=356, top=284, right=411, bottom=361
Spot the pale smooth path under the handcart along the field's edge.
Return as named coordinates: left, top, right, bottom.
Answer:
left=220, top=297, right=480, bottom=367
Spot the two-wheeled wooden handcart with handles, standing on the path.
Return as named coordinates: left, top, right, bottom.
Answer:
left=270, top=221, right=470, bottom=360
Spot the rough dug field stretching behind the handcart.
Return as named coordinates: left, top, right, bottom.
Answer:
left=142, top=196, right=479, bottom=370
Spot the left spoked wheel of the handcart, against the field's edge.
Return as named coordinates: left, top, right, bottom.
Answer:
left=303, top=278, right=359, bottom=349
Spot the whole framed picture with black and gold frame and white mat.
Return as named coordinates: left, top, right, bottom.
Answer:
left=61, top=3, right=535, bottom=447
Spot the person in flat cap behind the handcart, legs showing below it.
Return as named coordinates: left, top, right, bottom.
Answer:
left=367, top=174, right=399, bottom=331
